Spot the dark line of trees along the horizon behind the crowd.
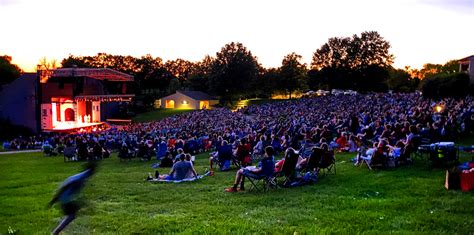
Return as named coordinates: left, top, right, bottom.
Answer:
left=0, top=31, right=465, bottom=104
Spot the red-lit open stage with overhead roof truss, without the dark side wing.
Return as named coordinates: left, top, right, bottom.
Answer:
left=39, top=68, right=134, bottom=132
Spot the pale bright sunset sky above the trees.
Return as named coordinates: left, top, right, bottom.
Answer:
left=0, top=0, right=474, bottom=71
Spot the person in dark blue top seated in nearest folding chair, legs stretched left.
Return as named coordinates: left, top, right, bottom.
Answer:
left=225, top=146, right=275, bottom=192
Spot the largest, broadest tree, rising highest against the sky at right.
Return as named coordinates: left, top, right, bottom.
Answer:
left=311, top=31, right=394, bottom=91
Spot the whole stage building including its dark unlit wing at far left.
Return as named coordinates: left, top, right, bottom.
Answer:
left=0, top=68, right=134, bottom=132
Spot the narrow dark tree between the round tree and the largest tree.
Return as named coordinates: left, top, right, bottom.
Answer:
left=276, top=52, right=307, bottom=99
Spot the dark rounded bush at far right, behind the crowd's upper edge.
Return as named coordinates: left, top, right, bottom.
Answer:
left=421, top=73, right=472, bottom=99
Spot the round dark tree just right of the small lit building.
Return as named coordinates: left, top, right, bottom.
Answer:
left=209, top=42, right=259, bottom=103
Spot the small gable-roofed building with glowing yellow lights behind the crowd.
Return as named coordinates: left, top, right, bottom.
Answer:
left=160, top=91, right=219, bottom=109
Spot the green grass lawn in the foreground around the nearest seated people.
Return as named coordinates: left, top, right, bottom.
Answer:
left=0, top=147, right=474, bottom=234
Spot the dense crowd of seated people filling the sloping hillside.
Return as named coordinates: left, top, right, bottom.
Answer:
left=4, top=93, right=474, bottom=170
